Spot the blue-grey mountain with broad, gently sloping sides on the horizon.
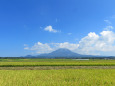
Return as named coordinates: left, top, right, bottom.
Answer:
left=25, top=48, right=100, bottom=58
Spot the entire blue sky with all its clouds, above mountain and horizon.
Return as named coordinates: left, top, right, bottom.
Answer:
left=0, top=0, right=115, bottom=56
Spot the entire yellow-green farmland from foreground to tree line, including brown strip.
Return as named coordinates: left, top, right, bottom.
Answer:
left=0, top=59, right=115, bottom=86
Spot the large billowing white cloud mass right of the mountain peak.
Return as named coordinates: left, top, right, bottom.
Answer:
left=78, top=31, right=115, bottom=54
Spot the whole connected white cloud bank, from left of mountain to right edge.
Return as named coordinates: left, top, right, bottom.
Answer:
left=24, top=27, right=115, bottom=55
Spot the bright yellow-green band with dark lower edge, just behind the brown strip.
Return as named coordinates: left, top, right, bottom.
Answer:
left=0, top=60, right=115, bottom=67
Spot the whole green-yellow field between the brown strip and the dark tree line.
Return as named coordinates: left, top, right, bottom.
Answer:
left=0, top=59, right=115, bottom=67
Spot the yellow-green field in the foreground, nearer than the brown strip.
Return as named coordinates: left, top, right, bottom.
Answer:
left=0, top=69, right=115, bottom=86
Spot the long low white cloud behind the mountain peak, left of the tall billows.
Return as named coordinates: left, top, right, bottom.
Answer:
left=24, top=42, right=79, bottom=54
